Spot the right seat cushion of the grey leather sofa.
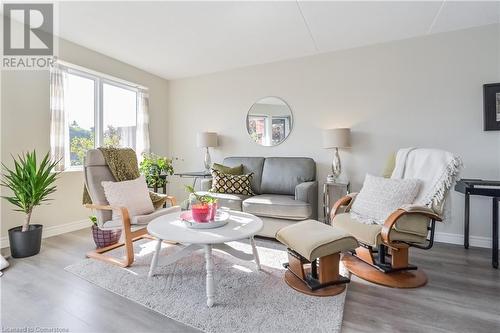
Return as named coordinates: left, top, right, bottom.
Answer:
left=242, top=194, right=312, bottom=220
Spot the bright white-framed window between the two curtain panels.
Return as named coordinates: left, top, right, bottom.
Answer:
left=56, top=66, right=147, bottom=169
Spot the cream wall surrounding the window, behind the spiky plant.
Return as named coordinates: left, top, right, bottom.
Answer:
left=1, top=40, right=168, bottom=241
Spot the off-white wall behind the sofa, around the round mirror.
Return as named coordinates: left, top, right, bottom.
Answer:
left=168, top=26, right=500, bottom=243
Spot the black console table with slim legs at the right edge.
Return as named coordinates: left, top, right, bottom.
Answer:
left=455, top=179, right=500, bottom=268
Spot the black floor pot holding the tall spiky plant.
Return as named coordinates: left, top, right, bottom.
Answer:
left=9, top=224, right=43, bottom=258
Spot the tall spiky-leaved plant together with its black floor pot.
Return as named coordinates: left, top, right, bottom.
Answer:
left=0, top=151, right=58, bottom=258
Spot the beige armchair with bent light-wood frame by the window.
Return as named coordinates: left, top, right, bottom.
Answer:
left=84, top=149, right=180, bottom=267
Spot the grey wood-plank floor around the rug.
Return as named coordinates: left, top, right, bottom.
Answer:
left=0, top=230, right=500, bottom=333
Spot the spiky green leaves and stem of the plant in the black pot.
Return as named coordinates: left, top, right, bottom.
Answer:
left=0, top=150, right=58, bottom=232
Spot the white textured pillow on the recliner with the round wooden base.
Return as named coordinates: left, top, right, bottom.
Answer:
left=351, top=174, right=420, bottom=224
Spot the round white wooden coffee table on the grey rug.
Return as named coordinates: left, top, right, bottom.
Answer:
left=148, top=211, right=263, bottom=307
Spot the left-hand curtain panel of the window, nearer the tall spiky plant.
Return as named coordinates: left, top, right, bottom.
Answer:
left=50, top=64, right=69, bottom=171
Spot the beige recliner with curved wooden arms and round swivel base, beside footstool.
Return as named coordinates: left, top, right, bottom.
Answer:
left=330, top=149, right=459, bottom=288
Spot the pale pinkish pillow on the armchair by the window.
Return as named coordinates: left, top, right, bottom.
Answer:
left=101, top=176, right=154, bottom=220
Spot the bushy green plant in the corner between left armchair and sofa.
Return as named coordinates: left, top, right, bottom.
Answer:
left=139, top=153, right=177, bottom=187
